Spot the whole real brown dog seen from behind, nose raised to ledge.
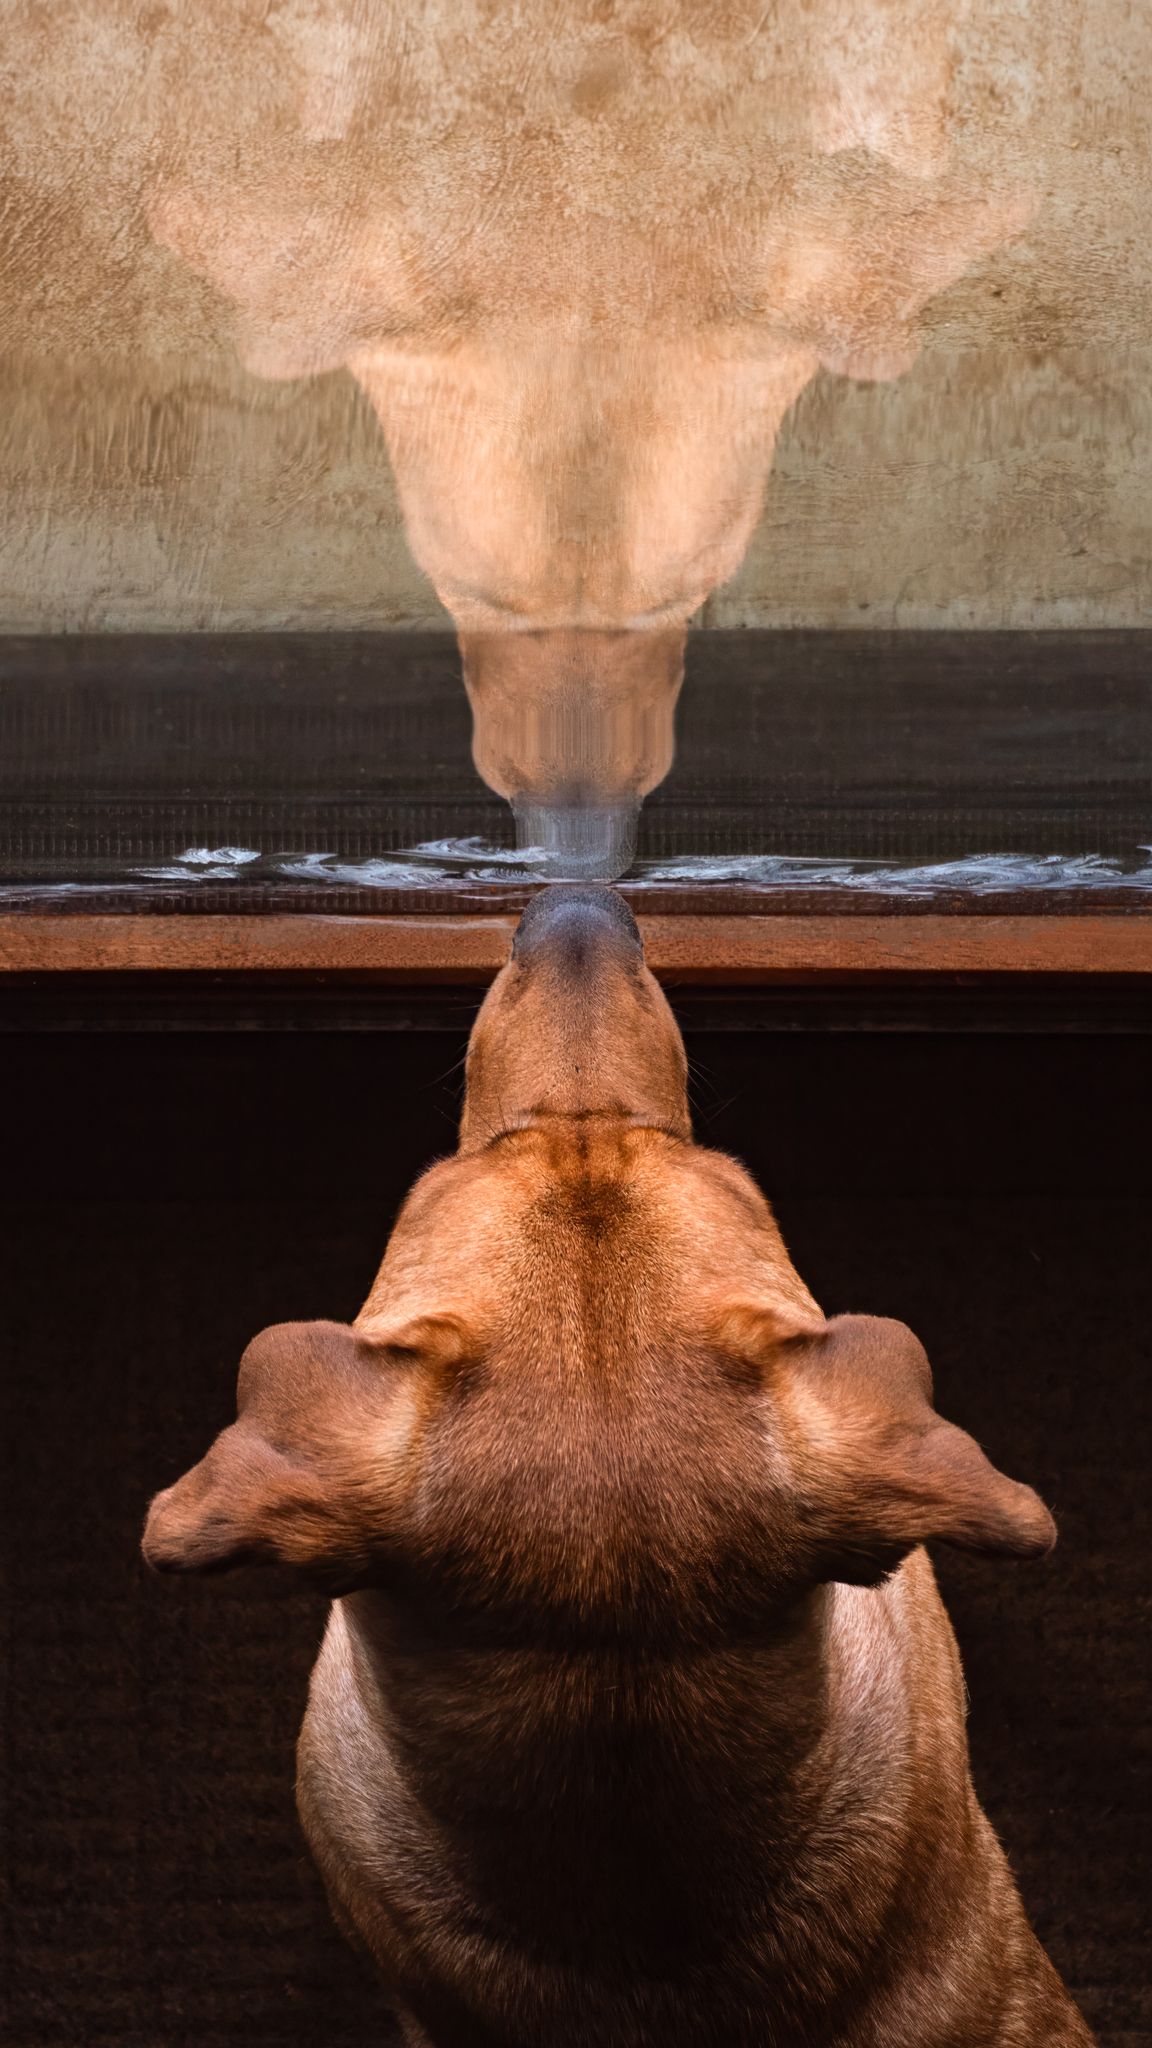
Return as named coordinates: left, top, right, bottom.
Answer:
left=143, top=889, right=1091, bottom=2048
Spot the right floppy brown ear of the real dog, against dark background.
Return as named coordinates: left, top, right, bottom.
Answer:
left=725, top=1315, right=1056, bottom=1585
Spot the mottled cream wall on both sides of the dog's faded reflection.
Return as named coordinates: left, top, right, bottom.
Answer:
left=0, top=0, right=1152, bottom=633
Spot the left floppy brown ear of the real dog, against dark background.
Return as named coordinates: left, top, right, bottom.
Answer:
left=143, top=1315, right=463, bottom=1589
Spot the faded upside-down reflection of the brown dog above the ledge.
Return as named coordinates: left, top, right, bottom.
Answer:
left=143, top=0, right=1020, bottom=847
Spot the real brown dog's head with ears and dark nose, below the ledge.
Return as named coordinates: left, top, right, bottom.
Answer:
left=143, top=889, right=1054, bottom=1634
